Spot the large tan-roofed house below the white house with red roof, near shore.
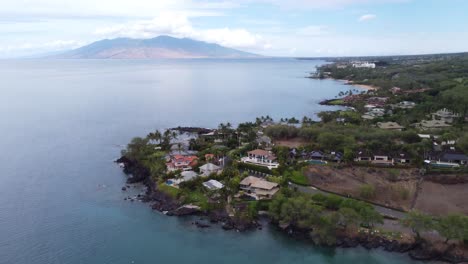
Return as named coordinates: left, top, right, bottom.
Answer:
left=240, top=176, right=279, bottom=200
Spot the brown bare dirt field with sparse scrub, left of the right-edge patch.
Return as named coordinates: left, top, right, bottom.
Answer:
left=306, top=165, right=420, bottom=210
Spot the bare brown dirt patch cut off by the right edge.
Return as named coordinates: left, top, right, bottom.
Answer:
left=414, top=181, right=468, bottom=215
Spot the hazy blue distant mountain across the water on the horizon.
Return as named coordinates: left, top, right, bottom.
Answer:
left=52, top=36, right=260, bottom=59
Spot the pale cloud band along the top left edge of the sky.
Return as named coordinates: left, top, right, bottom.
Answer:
left=0, top=0, right=234, bottom=20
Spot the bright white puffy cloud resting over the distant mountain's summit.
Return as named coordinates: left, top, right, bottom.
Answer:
left=94, top=13, right=271, bottom=50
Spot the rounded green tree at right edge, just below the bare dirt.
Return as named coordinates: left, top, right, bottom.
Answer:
left=435, top=214, right=468, bottom=243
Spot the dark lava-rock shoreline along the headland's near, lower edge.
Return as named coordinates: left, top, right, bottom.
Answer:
left=116, top=157, right=468, bottom=263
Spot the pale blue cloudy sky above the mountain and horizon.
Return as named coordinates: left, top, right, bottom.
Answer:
left=0, top=0, right=468, bottom=58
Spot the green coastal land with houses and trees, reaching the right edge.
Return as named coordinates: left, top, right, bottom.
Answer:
left=117, top=54, right=468, bottom=263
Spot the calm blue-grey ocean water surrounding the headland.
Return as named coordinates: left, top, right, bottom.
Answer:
left=0, top=59, right=412, bottom=264
